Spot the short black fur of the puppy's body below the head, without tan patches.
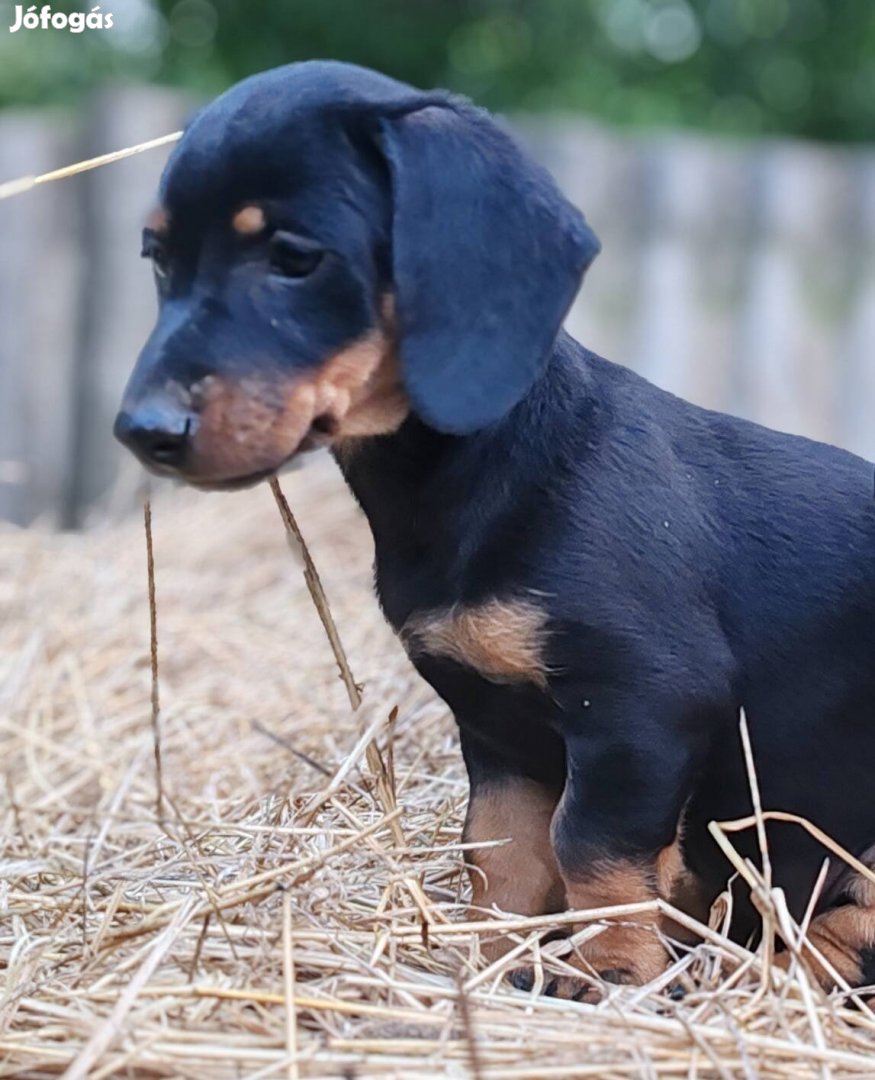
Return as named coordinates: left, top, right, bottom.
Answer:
left=347, top=337, right=875, bottom=929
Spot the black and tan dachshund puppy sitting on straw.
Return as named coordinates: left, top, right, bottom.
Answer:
left=116, top=62, right=875, bottom=996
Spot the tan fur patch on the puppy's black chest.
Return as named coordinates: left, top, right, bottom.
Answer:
left=401, top=599, right=548, bottom=689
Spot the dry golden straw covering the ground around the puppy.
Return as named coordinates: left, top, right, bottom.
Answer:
left=0, top=461, right=875, bottom=1080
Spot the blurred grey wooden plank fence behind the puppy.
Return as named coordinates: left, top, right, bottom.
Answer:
left=0, top=89, right=875, bottom=525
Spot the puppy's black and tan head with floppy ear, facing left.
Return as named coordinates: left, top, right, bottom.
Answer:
left=116, top=62, right=598, bottom=486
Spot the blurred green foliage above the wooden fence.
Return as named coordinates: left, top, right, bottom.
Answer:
left=0, top=0, right=875, bottom=141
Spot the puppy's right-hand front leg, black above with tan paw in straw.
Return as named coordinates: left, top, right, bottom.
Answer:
left=550, top=699, right=695, bottom=997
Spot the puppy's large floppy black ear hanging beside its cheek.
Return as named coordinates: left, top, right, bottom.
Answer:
left=380, top=103, right=600, bottom=434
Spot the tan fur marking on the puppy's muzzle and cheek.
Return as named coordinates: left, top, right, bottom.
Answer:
left=188, top=308, right=409, bottom=483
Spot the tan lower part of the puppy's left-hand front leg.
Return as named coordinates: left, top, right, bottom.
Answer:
left=463, top=778, right=565, bottom=960
